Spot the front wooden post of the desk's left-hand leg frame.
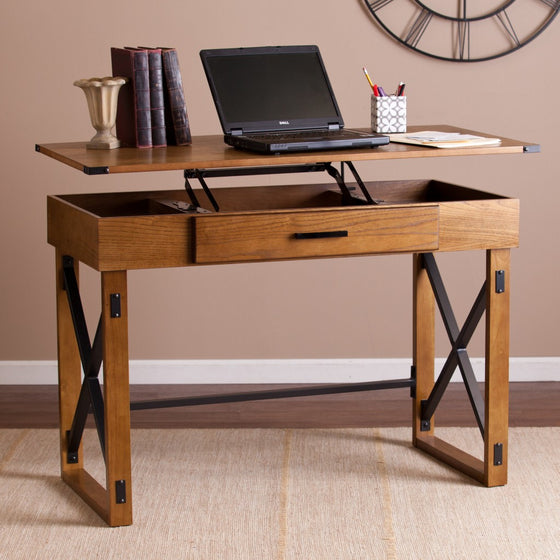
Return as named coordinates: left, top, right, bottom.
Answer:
left=101, top=271, right=132, bottom=526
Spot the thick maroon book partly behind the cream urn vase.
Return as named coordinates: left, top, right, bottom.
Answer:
left=111, top=47, right=152, bottom=148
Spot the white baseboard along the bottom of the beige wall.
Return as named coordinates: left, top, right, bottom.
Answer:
left=0, top=357, right=560, bottom=385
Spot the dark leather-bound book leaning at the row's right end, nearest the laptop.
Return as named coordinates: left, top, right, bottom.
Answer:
left=162, top=49, right=192, bottom=146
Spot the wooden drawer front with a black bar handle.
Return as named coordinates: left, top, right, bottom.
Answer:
left=194, top=204, right=439, bottom=264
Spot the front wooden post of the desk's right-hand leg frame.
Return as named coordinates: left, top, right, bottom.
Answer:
left=484, top=249, right=510, bottom=486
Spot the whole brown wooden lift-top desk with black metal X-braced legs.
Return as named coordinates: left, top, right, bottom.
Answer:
left=36, top=126, right=538, bottom=526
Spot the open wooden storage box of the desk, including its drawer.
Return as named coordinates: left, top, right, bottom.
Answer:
left=47, top=180, right=519, bottom=270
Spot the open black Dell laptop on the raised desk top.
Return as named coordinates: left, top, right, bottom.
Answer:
left=200, top=45, right=389, bottom=154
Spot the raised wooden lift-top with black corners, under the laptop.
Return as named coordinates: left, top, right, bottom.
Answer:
left=36, top=125, right=539, bottom=175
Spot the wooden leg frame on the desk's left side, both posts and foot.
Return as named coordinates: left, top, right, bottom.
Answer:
left=56, top=251, right=132, bottom=526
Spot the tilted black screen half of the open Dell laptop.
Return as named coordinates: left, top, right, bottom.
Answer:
left=200, top=46, right=343, bottom=133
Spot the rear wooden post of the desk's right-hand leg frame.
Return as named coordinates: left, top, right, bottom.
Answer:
left=412, top=254, right=435, bottom=445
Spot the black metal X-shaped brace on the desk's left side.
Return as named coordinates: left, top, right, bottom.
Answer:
left=63, top=256, right=105, bottom=463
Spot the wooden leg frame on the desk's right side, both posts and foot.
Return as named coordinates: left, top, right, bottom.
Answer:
left=413, top=249, right=510, bottom=486
